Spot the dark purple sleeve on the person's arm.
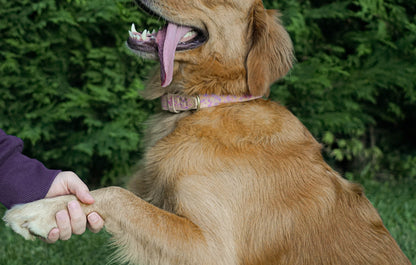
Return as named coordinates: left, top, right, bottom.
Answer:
left=0, top=129, right=60, bottom=208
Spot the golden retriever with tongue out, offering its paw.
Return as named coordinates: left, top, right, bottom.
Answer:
left=4, top=0, right=410, bottom=265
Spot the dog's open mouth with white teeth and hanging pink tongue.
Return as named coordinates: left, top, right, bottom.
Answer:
left=127, top=16, right=207, bottom=87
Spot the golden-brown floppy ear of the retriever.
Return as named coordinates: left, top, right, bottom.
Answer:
left=246, top=1, right=293, bottom=96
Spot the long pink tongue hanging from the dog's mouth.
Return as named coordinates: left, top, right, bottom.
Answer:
left=156, top=23, right=192, bottom=87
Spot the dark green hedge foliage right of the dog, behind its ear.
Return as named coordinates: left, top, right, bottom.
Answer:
left=265, top=0, right=416, bottom=178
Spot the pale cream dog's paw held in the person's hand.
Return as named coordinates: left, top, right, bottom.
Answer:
left=3, top=196, right=75, bottom=240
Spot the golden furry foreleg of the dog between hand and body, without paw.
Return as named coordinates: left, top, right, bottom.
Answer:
left=86, top=187, right=211, bottom=265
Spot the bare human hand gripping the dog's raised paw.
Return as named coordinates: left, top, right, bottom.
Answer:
left=45, top=171, right=104, bottom=243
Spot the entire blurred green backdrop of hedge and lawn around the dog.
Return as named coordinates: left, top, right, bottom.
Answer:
left=0, top=0, right=416, bottom=264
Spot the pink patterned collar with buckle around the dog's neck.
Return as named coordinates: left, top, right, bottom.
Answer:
left=162, top=93, right=261, bottom=113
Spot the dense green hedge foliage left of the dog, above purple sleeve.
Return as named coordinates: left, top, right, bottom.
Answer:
left=0, top=0, right=161, bottom=184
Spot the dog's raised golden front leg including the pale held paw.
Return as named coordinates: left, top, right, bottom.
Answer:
left=3, top=187, right=205, bottom=264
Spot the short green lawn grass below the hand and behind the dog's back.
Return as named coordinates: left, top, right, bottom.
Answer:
left=0, top=177, right=416, bottom=265
